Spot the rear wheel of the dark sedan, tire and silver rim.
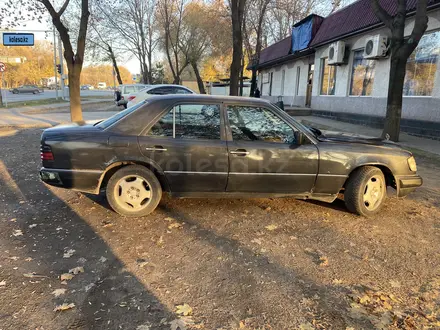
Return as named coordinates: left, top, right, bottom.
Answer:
left=106, top=165, right=162, bottom=217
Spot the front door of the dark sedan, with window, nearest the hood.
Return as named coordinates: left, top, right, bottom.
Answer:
left=226, top=104, right=319, bottom=194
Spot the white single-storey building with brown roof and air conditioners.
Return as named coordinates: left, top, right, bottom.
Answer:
left=254, top=0, right=440, bottom=138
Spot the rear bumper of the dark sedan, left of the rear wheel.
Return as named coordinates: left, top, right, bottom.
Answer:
left=40, top=167, right=104, bottom=194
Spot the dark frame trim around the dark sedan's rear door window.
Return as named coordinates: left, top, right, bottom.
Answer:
left=143, top=101, right=226, bottom=141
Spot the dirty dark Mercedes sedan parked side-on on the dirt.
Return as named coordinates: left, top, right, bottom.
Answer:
left=40, top=95, right=422, bottom=217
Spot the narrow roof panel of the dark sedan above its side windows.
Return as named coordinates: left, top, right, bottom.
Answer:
left=144, top=94, right=270, bottom=105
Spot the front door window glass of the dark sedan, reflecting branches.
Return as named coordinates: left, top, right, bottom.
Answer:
left=228, top=106, right=295, bottom=144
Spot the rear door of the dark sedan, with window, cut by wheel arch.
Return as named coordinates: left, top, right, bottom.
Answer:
left=139, top=103, right=228, bottom=192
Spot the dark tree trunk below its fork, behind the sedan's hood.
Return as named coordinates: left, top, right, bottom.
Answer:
left=382, top=52, right=407, bottom=142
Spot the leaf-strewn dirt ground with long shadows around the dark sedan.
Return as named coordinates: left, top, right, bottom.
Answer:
left=0, top=129, right=440, bottom=330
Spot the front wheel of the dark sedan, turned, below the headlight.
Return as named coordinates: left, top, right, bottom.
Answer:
left=344, top=166, right=387, bottom=217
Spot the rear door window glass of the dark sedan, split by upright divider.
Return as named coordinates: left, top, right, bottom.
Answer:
left=148, top=104, right=220, bottom=140
